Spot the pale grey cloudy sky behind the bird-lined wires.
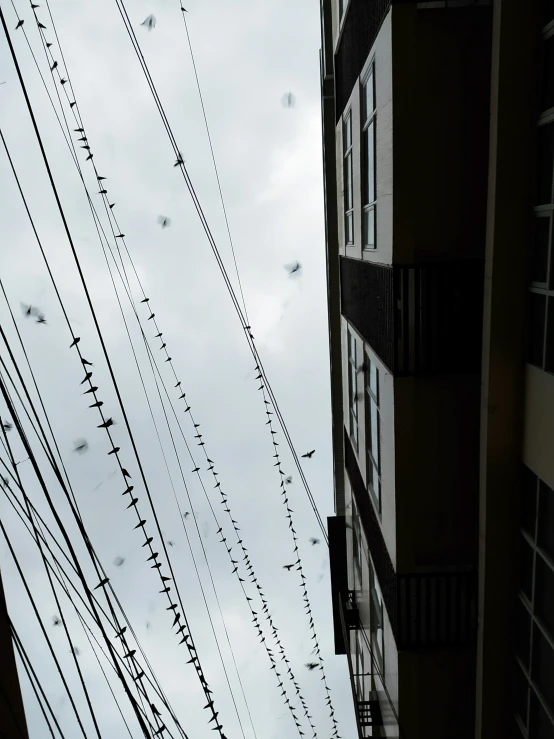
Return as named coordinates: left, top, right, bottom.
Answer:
left=0, top=0, right=355, bottom=739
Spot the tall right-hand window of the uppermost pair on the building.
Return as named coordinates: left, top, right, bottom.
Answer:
left=361, top=64, right=377, bottom=249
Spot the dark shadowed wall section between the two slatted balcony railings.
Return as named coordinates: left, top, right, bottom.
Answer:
left=394, top=375, right=480, bottom=572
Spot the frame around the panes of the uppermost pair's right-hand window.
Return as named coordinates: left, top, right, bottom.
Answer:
left=360, top=64, right=377, bottom=251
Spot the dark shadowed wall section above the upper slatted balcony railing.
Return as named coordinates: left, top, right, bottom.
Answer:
left=392, top=3, right=491, bottom=263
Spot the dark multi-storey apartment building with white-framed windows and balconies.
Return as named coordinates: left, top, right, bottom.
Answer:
left=321, top=0, right=554, bottom=739
